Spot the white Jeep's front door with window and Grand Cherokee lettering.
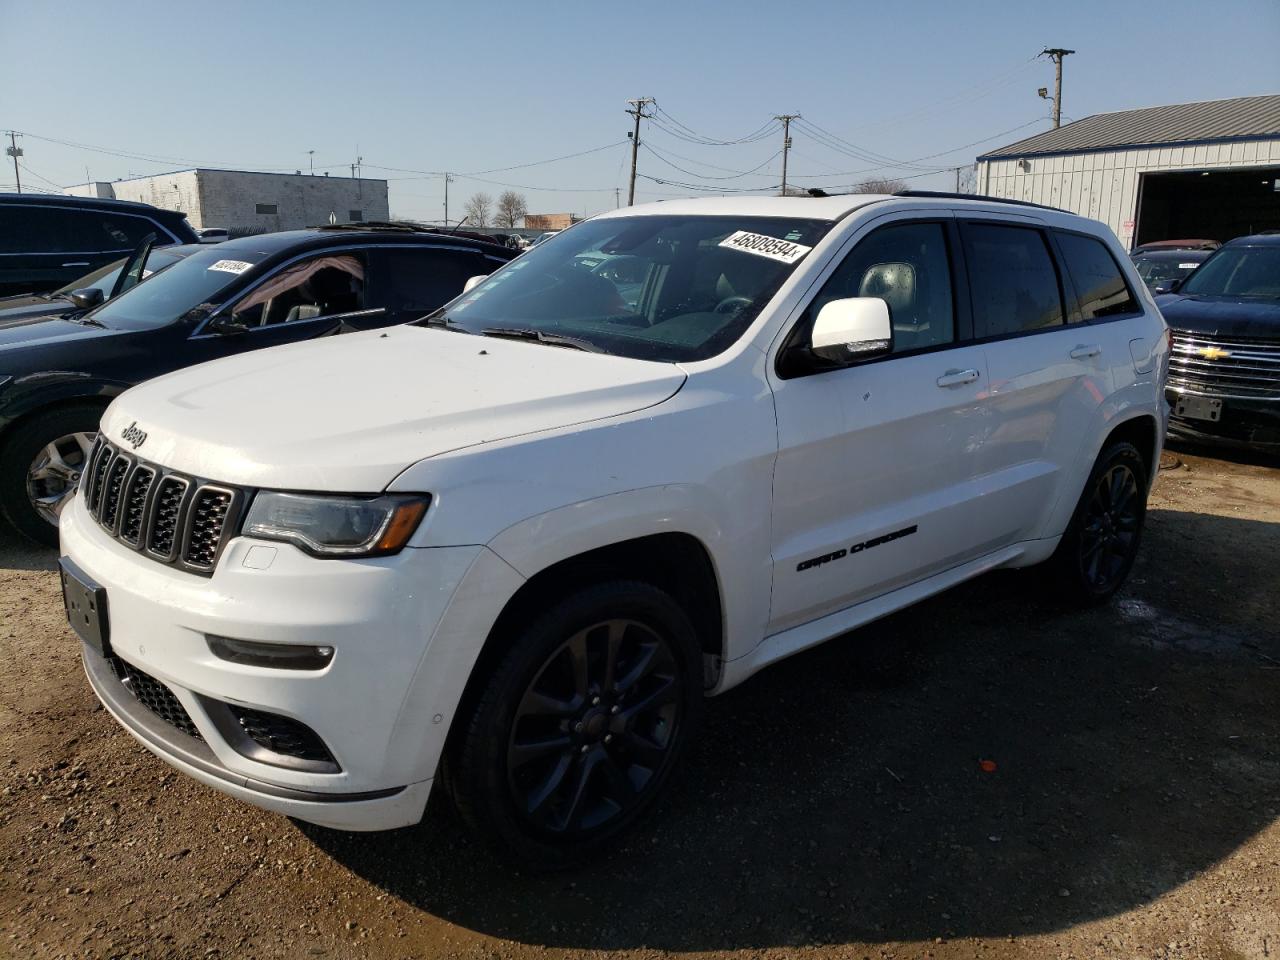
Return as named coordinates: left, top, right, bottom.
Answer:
left=769, top=215, right=1001, bottom=632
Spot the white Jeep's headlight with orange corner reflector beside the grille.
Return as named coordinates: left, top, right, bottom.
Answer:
left=242, top=490, right=431, bottom=557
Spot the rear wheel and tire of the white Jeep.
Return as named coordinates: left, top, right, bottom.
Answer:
left=1048, top=442, right=1148, bottom=607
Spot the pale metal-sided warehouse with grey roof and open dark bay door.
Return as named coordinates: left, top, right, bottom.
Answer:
left=977, top=96, right=1280, bottom=247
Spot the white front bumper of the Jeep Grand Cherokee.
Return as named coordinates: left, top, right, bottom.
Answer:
left=61, top=497, right=509, bottom=829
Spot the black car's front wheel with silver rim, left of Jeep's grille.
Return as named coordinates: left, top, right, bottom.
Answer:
left=0, top=403, right=102, bottom=547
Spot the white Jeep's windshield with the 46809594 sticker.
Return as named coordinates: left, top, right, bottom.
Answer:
left=429, top=215, right=831, bottom=362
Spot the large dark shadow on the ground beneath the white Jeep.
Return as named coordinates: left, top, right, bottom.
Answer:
left=302, top=511, right=1280, bottom=951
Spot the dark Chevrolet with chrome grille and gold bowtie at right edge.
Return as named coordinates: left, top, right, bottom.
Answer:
left=1156, top=234, right=1280, bottom=452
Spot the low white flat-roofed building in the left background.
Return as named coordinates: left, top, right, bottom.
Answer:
left=67, top=166, right=390, bottom=237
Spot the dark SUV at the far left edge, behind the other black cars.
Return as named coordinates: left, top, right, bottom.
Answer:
left=0, top=193, right=200, bottom=297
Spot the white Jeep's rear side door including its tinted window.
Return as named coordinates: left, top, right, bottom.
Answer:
left=960, top=215, right=1128, bottom=543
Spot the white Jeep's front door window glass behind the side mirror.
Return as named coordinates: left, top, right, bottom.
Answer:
left=809, top=223, right=955, bottom=353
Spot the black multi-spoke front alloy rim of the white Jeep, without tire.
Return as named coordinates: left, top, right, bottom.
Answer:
left=507, top=620, right=681, bottom=836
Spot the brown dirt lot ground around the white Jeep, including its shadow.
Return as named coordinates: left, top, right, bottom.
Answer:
left=0, top=453, right=1280, bottom=959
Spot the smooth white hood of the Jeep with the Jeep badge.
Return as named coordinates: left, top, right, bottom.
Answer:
left=102, top=326, right=685, bottom=493
